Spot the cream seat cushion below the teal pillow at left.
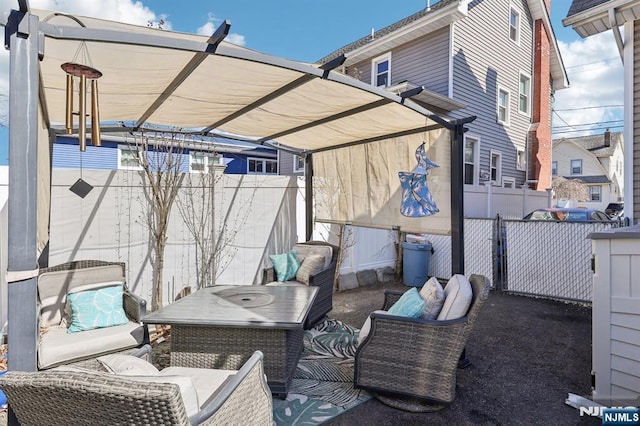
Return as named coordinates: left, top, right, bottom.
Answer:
left=38, top=321, right=144, bottom=369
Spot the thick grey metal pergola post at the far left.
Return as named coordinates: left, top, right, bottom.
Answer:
left=5, top=7, right=41, bottom=371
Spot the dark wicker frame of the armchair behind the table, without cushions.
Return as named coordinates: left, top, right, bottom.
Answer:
left=262, top=241, right=340, bottom=330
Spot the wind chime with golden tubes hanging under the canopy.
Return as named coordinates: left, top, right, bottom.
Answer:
left=60, top=41, right=102, bottom=151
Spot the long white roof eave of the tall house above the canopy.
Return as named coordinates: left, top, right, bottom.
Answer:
left=344, top=1, right=469, bottom=66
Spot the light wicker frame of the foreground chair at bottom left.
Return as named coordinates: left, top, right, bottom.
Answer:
left=0, top=351, right=273, bottom=426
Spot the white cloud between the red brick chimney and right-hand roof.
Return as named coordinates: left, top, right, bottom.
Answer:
left=553, top=31, right=624, bottom=138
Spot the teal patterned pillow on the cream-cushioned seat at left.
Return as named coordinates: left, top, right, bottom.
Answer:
left=67, top=285, right=129, bottom=333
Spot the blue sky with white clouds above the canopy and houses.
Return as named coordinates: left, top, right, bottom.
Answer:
left=0, top=0, right=623, bottom=164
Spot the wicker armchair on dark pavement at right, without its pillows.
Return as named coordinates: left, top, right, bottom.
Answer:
left=354, top=275, right=490, bottom=411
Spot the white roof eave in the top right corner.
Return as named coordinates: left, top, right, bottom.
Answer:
left=562, top=0, right=640, bottom=38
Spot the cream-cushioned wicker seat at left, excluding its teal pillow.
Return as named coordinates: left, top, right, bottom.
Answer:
left=38, top=260, right=150, bottom=370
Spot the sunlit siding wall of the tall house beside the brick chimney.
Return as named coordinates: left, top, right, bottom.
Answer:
left=452, top=0, right=533, bottom=186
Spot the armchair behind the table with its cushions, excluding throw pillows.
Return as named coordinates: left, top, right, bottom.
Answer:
left=262, top=241, right=340, bottom=329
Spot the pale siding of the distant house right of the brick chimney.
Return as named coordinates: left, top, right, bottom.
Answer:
left=553, top=141, right=619, bottom=211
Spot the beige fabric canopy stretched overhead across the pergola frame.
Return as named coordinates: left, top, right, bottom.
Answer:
left=31, top=10, right=448, bottom=152
